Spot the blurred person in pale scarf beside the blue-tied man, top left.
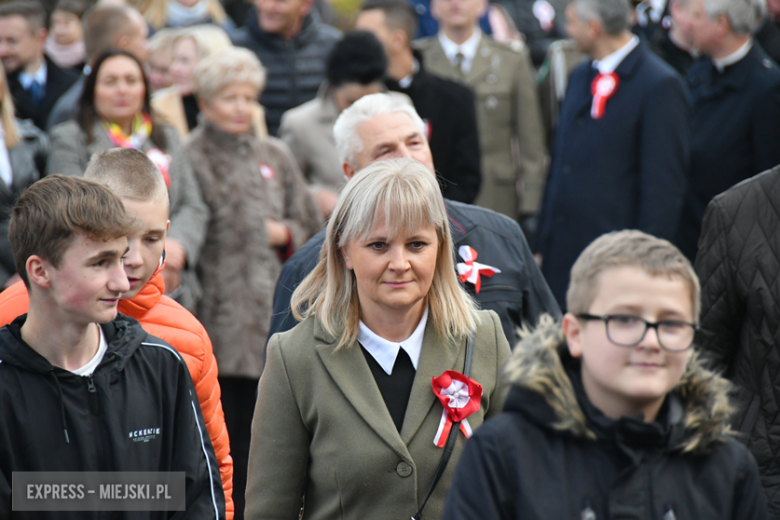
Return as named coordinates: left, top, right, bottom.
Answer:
left=44, top=0, right=87, bottom=73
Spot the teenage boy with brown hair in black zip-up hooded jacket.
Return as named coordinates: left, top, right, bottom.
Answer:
left=0, top=175, right=225, bottom=518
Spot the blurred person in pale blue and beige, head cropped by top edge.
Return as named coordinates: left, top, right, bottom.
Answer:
left=143, top=0, right=236, bottom=33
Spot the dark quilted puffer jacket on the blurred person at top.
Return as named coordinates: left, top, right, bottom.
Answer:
left=233, top=7, right=341, bottom=136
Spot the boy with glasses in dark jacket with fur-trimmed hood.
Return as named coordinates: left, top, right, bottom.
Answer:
left=442, top=231, right=769, bottom=520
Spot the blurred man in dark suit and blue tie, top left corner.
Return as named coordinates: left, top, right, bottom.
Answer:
left=0, top=0, right=78, bottom=129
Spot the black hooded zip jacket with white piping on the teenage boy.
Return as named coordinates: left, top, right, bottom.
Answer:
left=0, top=315, right=225, bottom=520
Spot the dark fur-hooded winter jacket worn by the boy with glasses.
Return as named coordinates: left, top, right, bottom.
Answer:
left=442, top=318, right=769, bottom=520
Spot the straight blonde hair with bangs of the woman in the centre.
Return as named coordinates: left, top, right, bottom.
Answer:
left=291, top=159, right=477, bottom=348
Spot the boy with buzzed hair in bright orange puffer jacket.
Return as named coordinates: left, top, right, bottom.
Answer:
left=0, top=148, right=233, bottom=520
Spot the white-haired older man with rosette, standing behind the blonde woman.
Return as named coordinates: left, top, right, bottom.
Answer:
left=269, top=94, right=560, bottom=345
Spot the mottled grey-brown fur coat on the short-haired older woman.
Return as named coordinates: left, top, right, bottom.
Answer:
left=187, top=120, right=322, bottom=378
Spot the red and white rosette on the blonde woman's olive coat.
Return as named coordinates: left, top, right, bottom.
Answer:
left=432, top=370, right=482, bottom=448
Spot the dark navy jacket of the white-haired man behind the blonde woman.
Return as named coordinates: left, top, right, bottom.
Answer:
left=268, top=199, right=561, bottom=347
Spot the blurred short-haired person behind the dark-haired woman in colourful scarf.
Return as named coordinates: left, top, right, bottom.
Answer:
left=46, top=4, right=149, bottom=131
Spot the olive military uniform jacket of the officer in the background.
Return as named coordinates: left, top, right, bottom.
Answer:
left=414, top=35, right=547, bottom=218
